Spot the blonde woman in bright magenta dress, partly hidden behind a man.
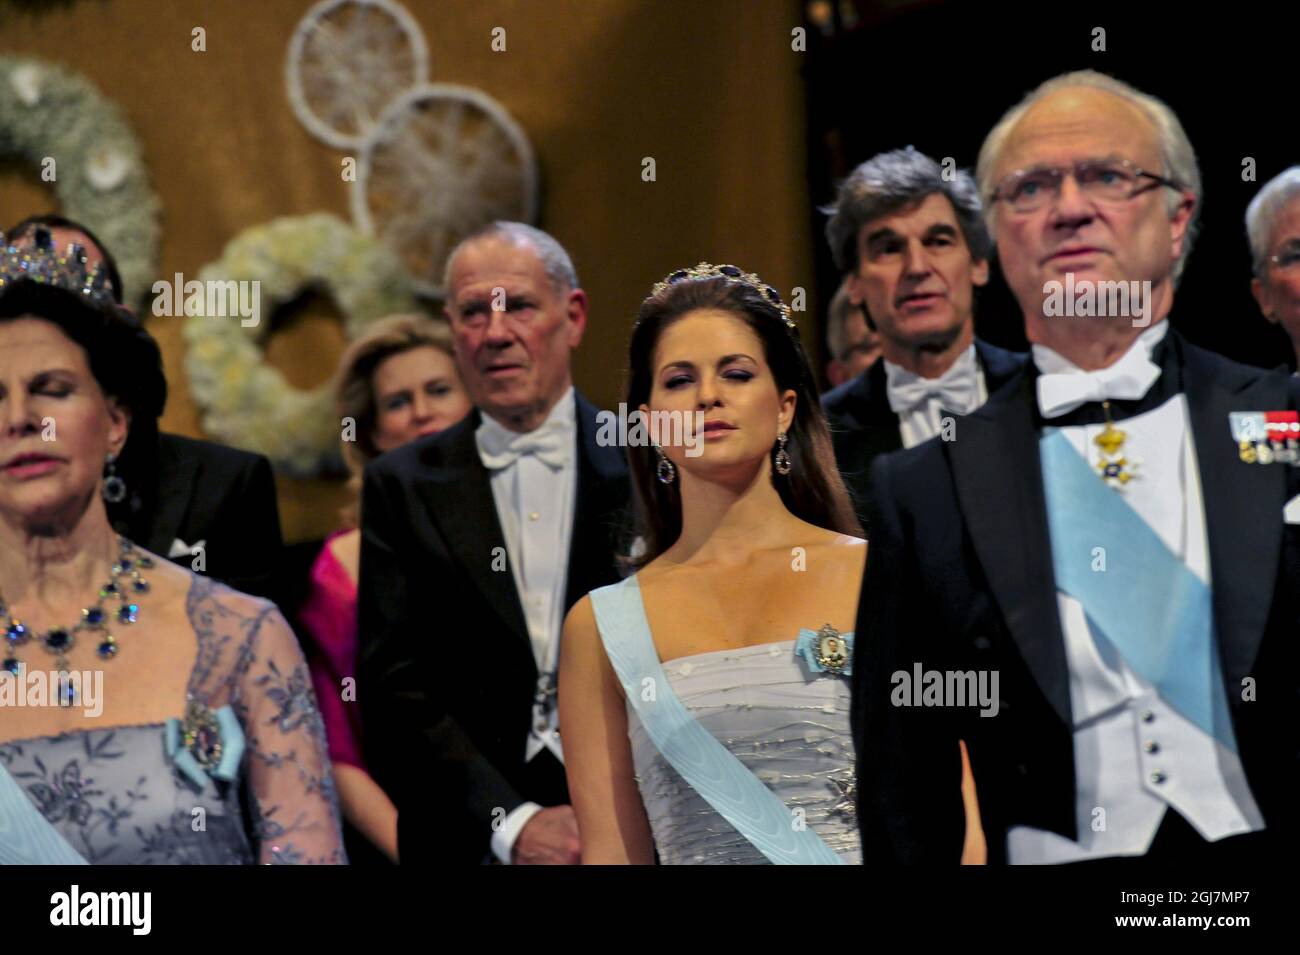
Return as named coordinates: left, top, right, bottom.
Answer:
left=299, top=314, right=471, bottom=863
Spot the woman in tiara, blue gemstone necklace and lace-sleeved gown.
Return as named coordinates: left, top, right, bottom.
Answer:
left=0, top=235, right=346, bottom=865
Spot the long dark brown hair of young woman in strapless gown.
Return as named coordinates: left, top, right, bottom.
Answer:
left=623, top=277, right=862, bottom=569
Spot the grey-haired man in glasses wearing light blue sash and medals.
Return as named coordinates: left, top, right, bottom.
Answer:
left=853, top=70, right=1300, bottom=865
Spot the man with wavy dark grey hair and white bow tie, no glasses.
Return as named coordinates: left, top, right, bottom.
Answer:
left=822, top=147, right=1024, bottom=526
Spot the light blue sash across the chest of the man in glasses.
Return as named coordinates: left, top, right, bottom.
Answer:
left=1039, top=429, right=1236, bottom=752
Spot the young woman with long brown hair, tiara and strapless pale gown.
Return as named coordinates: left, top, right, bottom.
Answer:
left=560, top=262, right=982, bottom=864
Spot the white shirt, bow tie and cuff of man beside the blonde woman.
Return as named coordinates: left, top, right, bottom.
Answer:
left=478, top=387, right=577, bottom=863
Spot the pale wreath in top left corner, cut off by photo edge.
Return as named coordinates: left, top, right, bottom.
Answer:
left=0, top=55, right=160, bottom=303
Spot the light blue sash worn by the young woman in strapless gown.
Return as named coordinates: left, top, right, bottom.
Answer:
left=592, top=576, right=844, bottom=865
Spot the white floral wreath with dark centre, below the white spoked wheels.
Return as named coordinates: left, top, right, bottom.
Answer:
left=183, top=213, right=415, bottom=477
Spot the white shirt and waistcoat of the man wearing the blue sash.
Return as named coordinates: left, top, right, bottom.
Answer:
left=1006, top=322, right=1264, bottom=864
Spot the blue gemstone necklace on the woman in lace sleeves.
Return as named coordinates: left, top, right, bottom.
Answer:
left=0, top=537, right=153, bottom=676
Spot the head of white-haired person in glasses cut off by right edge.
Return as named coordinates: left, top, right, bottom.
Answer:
left=1245, top=166, right=1300, bottom=374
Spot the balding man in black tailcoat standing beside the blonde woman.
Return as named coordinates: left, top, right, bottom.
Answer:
left=359, top=222, right=629, bottom=863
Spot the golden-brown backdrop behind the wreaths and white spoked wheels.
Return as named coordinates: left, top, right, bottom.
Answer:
left=0, top=0, right=818, bottom=542
